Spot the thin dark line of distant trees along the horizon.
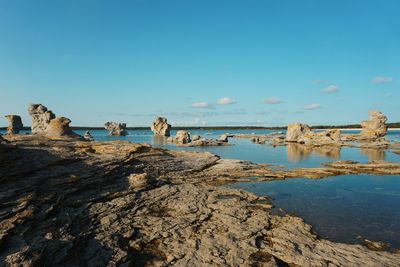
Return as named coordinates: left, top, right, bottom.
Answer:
left=0, top=122, right=400, bottom=131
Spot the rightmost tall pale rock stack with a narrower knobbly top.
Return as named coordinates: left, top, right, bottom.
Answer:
left=361, top=110, right=388, bottom=138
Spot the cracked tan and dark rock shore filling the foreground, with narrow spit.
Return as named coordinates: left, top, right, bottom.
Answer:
left=0, top=135, right=400, bottom=266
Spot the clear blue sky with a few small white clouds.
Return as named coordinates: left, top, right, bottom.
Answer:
left=0, top=0, right=400, bottom=126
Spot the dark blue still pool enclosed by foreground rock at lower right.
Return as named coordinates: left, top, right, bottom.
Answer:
left=232, top=175, right=400, bottom=251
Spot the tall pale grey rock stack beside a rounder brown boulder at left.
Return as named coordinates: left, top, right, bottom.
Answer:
left=28, top=104, right=56, bottom=134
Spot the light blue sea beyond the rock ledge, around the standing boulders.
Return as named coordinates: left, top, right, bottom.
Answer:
left=2, top=130, right=400, bottom=169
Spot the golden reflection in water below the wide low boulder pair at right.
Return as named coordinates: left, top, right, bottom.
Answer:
left=286, top=143, right=340, bottom=162
